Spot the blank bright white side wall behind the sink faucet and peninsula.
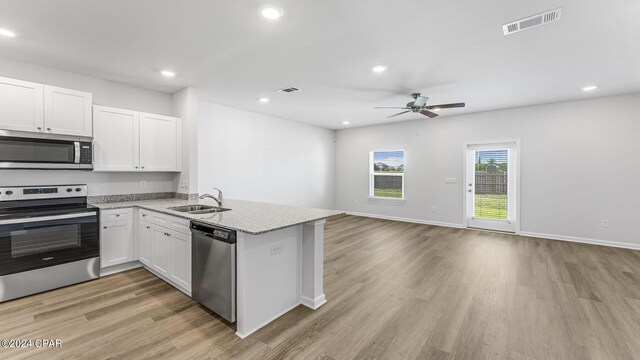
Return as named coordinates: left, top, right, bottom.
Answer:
left=198, top=101, right=335, bottom=208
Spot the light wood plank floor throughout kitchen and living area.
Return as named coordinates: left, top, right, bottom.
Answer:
left=0, top=216, right=640, bottom=360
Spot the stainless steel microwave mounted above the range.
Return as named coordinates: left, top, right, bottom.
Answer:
left=0, top=131, right=93, bottom=170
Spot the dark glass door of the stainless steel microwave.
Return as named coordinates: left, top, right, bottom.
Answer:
left=0, top=136, right=82, bottom=169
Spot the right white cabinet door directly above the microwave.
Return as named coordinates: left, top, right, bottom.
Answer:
left=44, top=85, right=93, bottom=136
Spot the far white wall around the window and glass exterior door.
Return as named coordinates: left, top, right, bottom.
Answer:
left=336, top=94, right=640, bottom=247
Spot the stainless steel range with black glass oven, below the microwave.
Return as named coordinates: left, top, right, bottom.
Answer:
left=0, top=185, right=100, bottom=301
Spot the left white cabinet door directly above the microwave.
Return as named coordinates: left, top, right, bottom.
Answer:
left=0, top=77, right=44, bottom=132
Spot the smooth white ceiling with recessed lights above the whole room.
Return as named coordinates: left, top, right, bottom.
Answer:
left=0, top=0, right=640, bottom=128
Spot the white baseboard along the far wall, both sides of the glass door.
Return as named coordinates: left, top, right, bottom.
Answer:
left=346, top=211, right=640, bottom=250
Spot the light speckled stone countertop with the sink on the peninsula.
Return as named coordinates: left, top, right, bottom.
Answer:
left=90, top=198, right=344, bottom=235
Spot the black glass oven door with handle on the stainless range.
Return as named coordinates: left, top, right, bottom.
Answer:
left=0, top=210, right=100, bottom=276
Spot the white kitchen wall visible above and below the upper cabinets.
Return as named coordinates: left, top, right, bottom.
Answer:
left=0, top=58, right=176, bottom=195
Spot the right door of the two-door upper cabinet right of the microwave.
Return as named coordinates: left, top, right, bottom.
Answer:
left=140, top=113, right=180, bottom=171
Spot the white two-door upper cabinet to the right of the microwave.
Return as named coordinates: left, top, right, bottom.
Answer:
left=93, top=105, right=181, bottom=172
